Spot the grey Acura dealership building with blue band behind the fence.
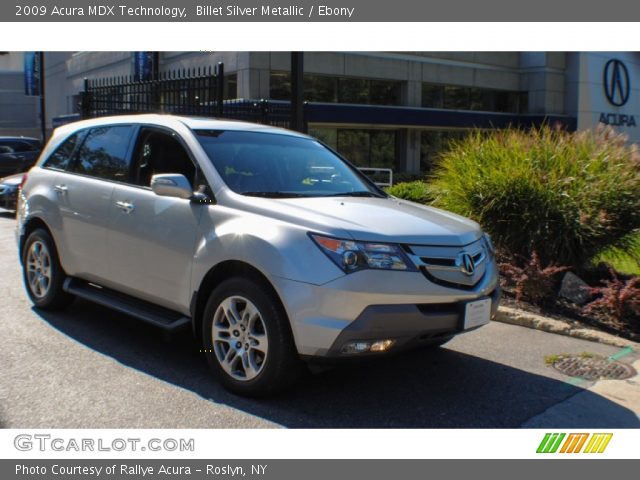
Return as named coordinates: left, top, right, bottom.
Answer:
left=45, top=52, right=640, bottom=173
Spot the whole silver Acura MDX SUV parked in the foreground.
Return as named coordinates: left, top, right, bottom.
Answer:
left=17, top=115, right=499, bottom=395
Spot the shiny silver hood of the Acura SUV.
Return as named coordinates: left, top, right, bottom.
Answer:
left=232, top=197, right=482, bottom=246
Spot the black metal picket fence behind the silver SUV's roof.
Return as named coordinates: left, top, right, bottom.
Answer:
left=80, top=63, right=306, bottom=130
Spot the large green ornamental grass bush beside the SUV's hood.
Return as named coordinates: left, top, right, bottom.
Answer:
left=428, top=127, right=640, bottom=269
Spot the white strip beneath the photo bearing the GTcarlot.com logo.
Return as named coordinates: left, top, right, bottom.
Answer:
left=0, top=428, right=639, bottom=460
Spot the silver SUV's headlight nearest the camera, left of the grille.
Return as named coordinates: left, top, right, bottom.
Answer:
left=310, top=234, right=416, bottom=273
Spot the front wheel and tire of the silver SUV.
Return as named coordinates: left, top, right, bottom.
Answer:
left=202, top=277, right=304, bottom=397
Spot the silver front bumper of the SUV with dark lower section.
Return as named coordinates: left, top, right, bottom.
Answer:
left=272, top=262, right=500, bottom=358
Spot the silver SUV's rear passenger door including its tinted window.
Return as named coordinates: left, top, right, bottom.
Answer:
left=54, top=125, right=134, bottom=282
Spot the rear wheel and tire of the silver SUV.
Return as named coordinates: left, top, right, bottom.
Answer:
left=22, top=228, right=74, bottom=310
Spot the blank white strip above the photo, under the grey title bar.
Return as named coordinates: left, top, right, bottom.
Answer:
left=0, top=22, right=640, bottom=51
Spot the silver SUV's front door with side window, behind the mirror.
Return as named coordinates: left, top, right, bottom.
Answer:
left=107, top=127, right=207, bottom=314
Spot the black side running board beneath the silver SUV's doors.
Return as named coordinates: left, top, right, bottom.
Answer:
left=62, top=278, right=191, bottom=331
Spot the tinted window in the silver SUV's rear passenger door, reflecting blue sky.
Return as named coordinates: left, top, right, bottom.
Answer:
left=72, top=126, right=132, bottom=182
